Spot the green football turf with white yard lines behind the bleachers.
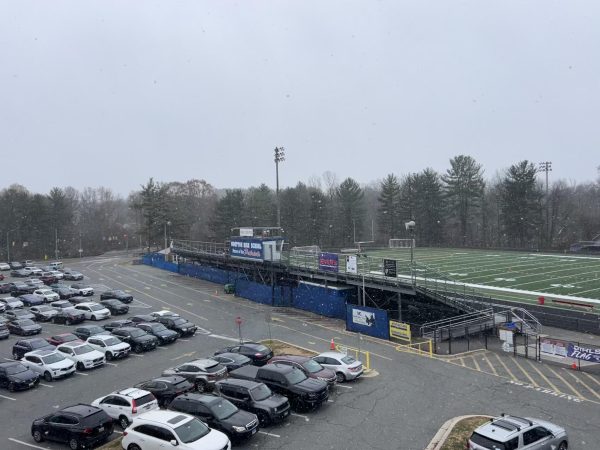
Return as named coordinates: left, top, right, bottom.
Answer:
left=364, top=248, right=600, bottom=306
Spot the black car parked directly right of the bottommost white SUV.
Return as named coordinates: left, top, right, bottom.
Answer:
left=169, top=394, right=259, bottom=441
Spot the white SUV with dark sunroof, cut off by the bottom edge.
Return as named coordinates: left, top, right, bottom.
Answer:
left=121, top=410, right=231, bottom=450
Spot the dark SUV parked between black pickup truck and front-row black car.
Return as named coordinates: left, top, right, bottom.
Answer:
left=215, top=378, right=291, bottom=425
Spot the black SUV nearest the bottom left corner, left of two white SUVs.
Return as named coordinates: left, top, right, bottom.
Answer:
left=31, top=403, right=114, bottom=449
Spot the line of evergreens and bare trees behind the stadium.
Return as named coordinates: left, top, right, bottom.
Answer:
left=0, top=155, right=600, bottom=259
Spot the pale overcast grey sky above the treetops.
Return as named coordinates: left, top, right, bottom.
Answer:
left=0, top=0, right=600, bottom=195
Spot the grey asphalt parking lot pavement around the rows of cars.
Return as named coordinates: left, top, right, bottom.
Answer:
left=0, top=255, right=600, bottom=450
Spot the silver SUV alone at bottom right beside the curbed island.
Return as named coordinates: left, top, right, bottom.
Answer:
left=467, top=414, right=569, bottom=450
